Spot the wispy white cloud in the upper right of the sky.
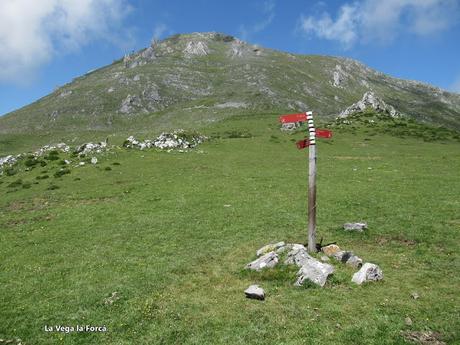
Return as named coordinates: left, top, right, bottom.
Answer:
left=300, top=0, right=460, bottom=48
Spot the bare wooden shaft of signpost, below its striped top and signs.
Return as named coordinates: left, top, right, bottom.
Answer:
left=308, top=144, right=316, bottom=253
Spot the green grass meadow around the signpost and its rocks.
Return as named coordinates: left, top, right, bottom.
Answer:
left=0, top=115, right=460, bottom=345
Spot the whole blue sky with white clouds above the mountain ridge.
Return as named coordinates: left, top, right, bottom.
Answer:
left=0, top=0, right=460, bottom=114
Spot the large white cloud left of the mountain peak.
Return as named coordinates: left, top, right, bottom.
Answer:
left=0, top=0, right=131, bottom=83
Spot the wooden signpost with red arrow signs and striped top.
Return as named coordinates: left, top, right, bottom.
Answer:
left=280, top=111, right=332, bottom=253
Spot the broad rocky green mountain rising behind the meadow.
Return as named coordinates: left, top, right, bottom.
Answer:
left=0, top=33, right=460, bottom=133
